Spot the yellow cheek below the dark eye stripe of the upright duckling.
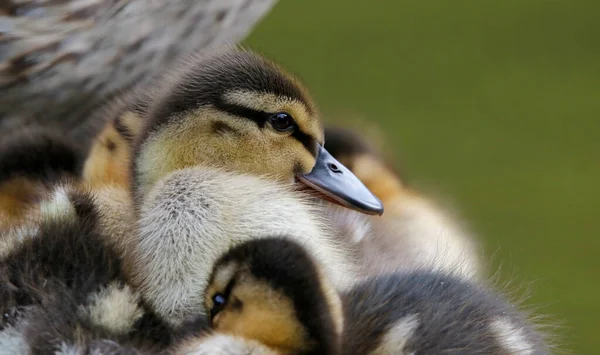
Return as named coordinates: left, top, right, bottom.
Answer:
left=136, top=107, right=315, bottom=200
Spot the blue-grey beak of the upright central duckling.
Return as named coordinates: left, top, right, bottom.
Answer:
left=298, top=145, right=383, bottom=216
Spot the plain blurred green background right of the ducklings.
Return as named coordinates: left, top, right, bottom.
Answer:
left=245, top=0, right=600, bottom=354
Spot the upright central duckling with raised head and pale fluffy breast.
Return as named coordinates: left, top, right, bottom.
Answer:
left=116, top=49, right=383, bottom=324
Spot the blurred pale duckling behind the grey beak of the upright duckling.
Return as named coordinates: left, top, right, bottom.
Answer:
left=325, top=127, right=483, bottom=278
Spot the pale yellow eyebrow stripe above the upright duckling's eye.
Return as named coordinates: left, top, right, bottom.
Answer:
left=224, top=90, right=324, bottom=144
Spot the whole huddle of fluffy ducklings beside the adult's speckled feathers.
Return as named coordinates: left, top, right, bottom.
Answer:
left=0, top=48, right=549, bottom=355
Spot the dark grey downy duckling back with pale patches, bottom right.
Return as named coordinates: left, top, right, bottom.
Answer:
left=341, top=271, right=549, bottom=355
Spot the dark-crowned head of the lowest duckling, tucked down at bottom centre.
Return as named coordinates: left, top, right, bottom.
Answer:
left=205, top=238, right=342, bottom=354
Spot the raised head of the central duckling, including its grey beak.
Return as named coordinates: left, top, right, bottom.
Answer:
left=132, top=48, right=383, bottom=214
